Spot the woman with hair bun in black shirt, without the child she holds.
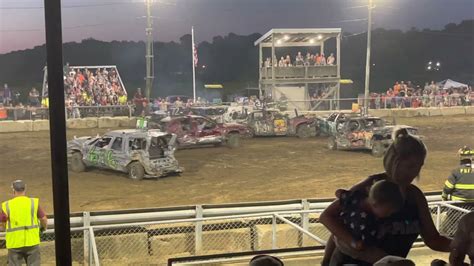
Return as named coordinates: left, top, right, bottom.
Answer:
left=320, top=129, right=451, bottom=265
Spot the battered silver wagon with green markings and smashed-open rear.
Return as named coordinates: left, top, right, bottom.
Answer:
left=67, top=129, right=182, bottom=180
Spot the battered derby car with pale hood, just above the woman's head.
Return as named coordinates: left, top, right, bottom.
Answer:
left=328, top=117, right=418, bottom=157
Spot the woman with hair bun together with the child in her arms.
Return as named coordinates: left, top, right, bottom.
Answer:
left=320, top=129, right=451, bottom=265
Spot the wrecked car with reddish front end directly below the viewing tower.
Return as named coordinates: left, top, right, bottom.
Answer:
left=247, top=109, right=317, bottom=138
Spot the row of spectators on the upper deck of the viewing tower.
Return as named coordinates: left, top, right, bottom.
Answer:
left=263, top=52, right=336, bottom=67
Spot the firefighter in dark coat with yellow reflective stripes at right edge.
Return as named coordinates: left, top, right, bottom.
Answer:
left=442, top=146, right=474, bottom=202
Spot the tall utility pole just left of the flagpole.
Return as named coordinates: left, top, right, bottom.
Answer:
left=145, top=0, right=154, bottom=101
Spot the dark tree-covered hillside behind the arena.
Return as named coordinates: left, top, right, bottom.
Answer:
left=0, top=20, right=474, bottom=101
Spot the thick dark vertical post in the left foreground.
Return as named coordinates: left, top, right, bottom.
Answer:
left=44, top=0, right=72, bottom=266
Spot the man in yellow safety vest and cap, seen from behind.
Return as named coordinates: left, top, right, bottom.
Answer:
left=0, top=180, right=48, bottom=265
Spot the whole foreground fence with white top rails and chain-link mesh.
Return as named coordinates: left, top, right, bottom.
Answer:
left=0, top=195, right=466, bottom=265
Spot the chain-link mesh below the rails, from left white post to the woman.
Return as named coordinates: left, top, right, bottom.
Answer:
left=86, top=211, right=322, bottom=265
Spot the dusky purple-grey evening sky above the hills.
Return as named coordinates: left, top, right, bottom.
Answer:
left=0, top=0, right=474, bottom=54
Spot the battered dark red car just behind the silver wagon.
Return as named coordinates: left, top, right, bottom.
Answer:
left=160, top=115, right=250, bottom=148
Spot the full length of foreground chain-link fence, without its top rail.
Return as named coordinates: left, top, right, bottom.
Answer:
left=0, top=202, right=474, bottom=265
